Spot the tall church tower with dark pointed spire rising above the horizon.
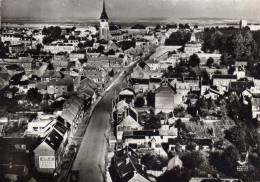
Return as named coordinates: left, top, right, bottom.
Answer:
left=99, top=0, right=109, bottom=40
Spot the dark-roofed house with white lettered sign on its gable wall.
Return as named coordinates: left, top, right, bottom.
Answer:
left=34, top=119, right=68, bottom=174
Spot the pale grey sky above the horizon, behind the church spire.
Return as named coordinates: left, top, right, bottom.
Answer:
left=0, top=0, right=260, bottom=20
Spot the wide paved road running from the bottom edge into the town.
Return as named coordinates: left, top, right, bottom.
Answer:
left=73, top=61, right=138, bottom=182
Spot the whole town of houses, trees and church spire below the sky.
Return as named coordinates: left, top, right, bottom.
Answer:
left=0, top=0, right=260, bottom=182
